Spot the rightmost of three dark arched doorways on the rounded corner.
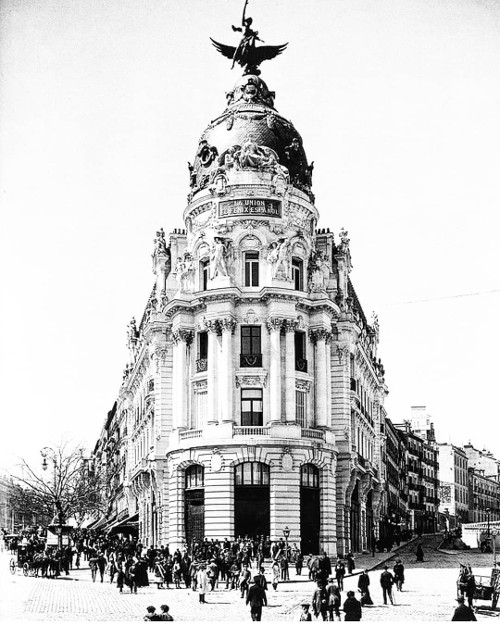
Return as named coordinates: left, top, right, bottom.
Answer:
left=300, top=464, right=320, bottom=554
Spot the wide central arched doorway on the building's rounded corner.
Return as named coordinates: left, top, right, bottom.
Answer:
left=234, top=462, right=271, bottom=537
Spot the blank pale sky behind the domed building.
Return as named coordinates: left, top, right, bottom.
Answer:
left=0, top=0, right=500, bottom=469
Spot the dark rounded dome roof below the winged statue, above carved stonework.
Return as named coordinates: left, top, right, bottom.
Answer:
left=190, top=75, right=312, bottom=199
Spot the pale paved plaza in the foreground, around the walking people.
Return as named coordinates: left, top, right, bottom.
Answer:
left=0, top=545, right=500, bottom=622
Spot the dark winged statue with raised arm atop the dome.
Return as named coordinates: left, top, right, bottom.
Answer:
left=210, top=0, right=288, bottom=76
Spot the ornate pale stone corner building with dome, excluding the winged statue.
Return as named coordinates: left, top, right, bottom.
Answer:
left=95, top=23, right=387, bottom=555
